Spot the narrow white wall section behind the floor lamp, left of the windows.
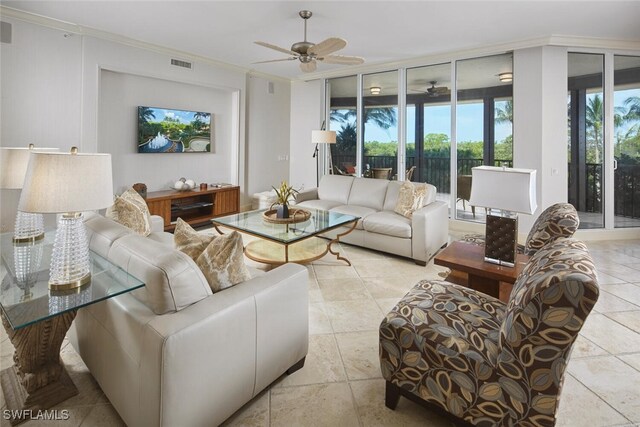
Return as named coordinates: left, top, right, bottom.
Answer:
left=289, top=80, right=324, bottom=188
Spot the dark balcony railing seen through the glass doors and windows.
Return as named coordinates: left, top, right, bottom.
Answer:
left=333, top=155, right=640, bottom=218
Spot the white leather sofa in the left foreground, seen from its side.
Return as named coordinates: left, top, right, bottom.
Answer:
left=70, top=214, right=309, bottom=427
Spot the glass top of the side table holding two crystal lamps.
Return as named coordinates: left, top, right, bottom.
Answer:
left=0, top=232, right=145, bottom=329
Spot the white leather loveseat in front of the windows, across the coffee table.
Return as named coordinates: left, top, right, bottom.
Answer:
left=296, top=175, right=449, bottom=265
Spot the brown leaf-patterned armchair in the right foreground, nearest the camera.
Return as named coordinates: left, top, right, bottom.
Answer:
left=380, top=239, right=598, bottom=426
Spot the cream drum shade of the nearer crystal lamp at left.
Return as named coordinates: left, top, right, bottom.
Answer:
left=18, top=152, right=113, bottom=213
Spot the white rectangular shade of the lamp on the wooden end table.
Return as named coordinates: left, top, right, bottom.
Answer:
left=469, top=166, right=537, bottom=215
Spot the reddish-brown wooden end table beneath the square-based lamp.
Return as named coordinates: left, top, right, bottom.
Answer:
left=434, top=242, right=529, bottom=301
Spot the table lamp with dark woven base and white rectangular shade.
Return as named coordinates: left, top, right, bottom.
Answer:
left=469, top=166, right=537, bottom=267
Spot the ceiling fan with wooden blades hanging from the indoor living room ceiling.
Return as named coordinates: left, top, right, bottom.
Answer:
left=254, top=10, right=364, bottom=73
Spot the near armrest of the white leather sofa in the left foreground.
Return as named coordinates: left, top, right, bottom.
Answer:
left=140, top=264, right=309, bottom=425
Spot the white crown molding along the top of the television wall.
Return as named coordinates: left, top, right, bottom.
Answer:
left=0, top=5, right=291, bottom=82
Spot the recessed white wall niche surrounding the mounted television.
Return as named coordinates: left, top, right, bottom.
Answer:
left=98, top=69, right=236, bottom=193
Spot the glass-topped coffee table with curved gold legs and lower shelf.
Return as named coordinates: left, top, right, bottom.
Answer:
left=211, top=208, right=360, bottom=265
